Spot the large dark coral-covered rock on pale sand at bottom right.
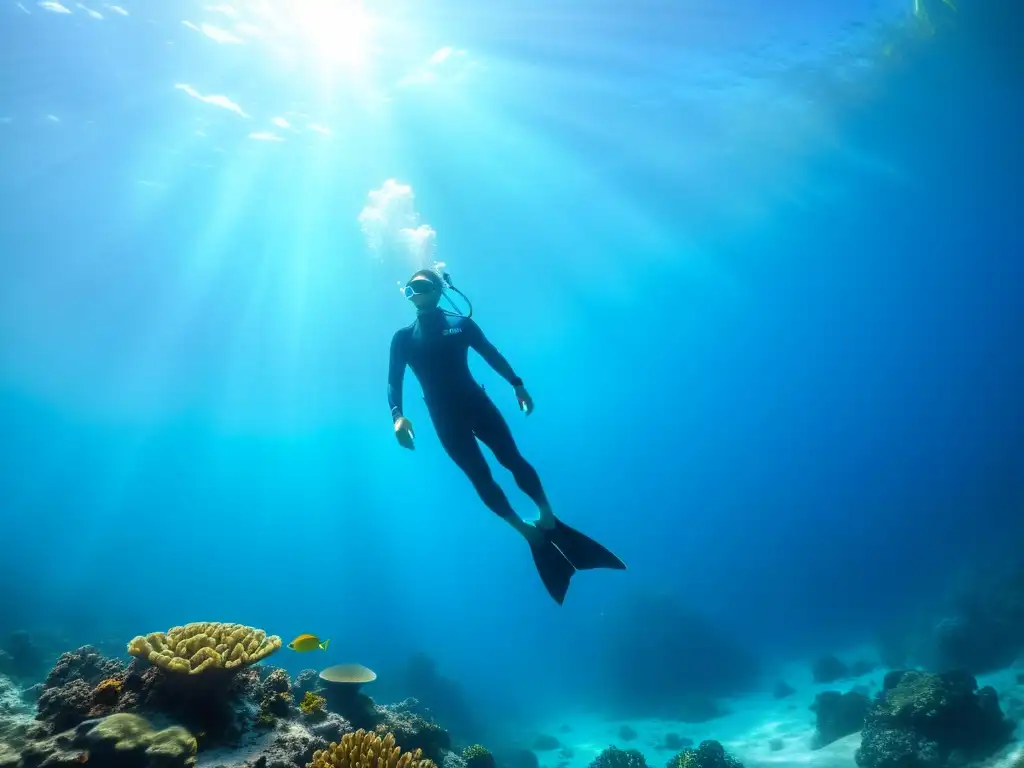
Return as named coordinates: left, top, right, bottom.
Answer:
left=856, top=671, right=1014, bottom=768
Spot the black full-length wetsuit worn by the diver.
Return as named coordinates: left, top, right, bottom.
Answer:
left=387, top=309, right=546, bottom=517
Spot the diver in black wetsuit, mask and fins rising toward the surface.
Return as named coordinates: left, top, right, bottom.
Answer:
left=388, top=269, right=626, bottom=605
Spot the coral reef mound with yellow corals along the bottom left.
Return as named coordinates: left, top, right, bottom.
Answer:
left=0, top=624, right=468, bottom=768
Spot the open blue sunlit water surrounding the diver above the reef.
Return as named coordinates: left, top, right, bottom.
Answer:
left=0, top=0, right=1024, bottom=749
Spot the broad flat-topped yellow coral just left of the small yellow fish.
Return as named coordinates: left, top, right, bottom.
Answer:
left=128, top=622, right=281, bottom=675
